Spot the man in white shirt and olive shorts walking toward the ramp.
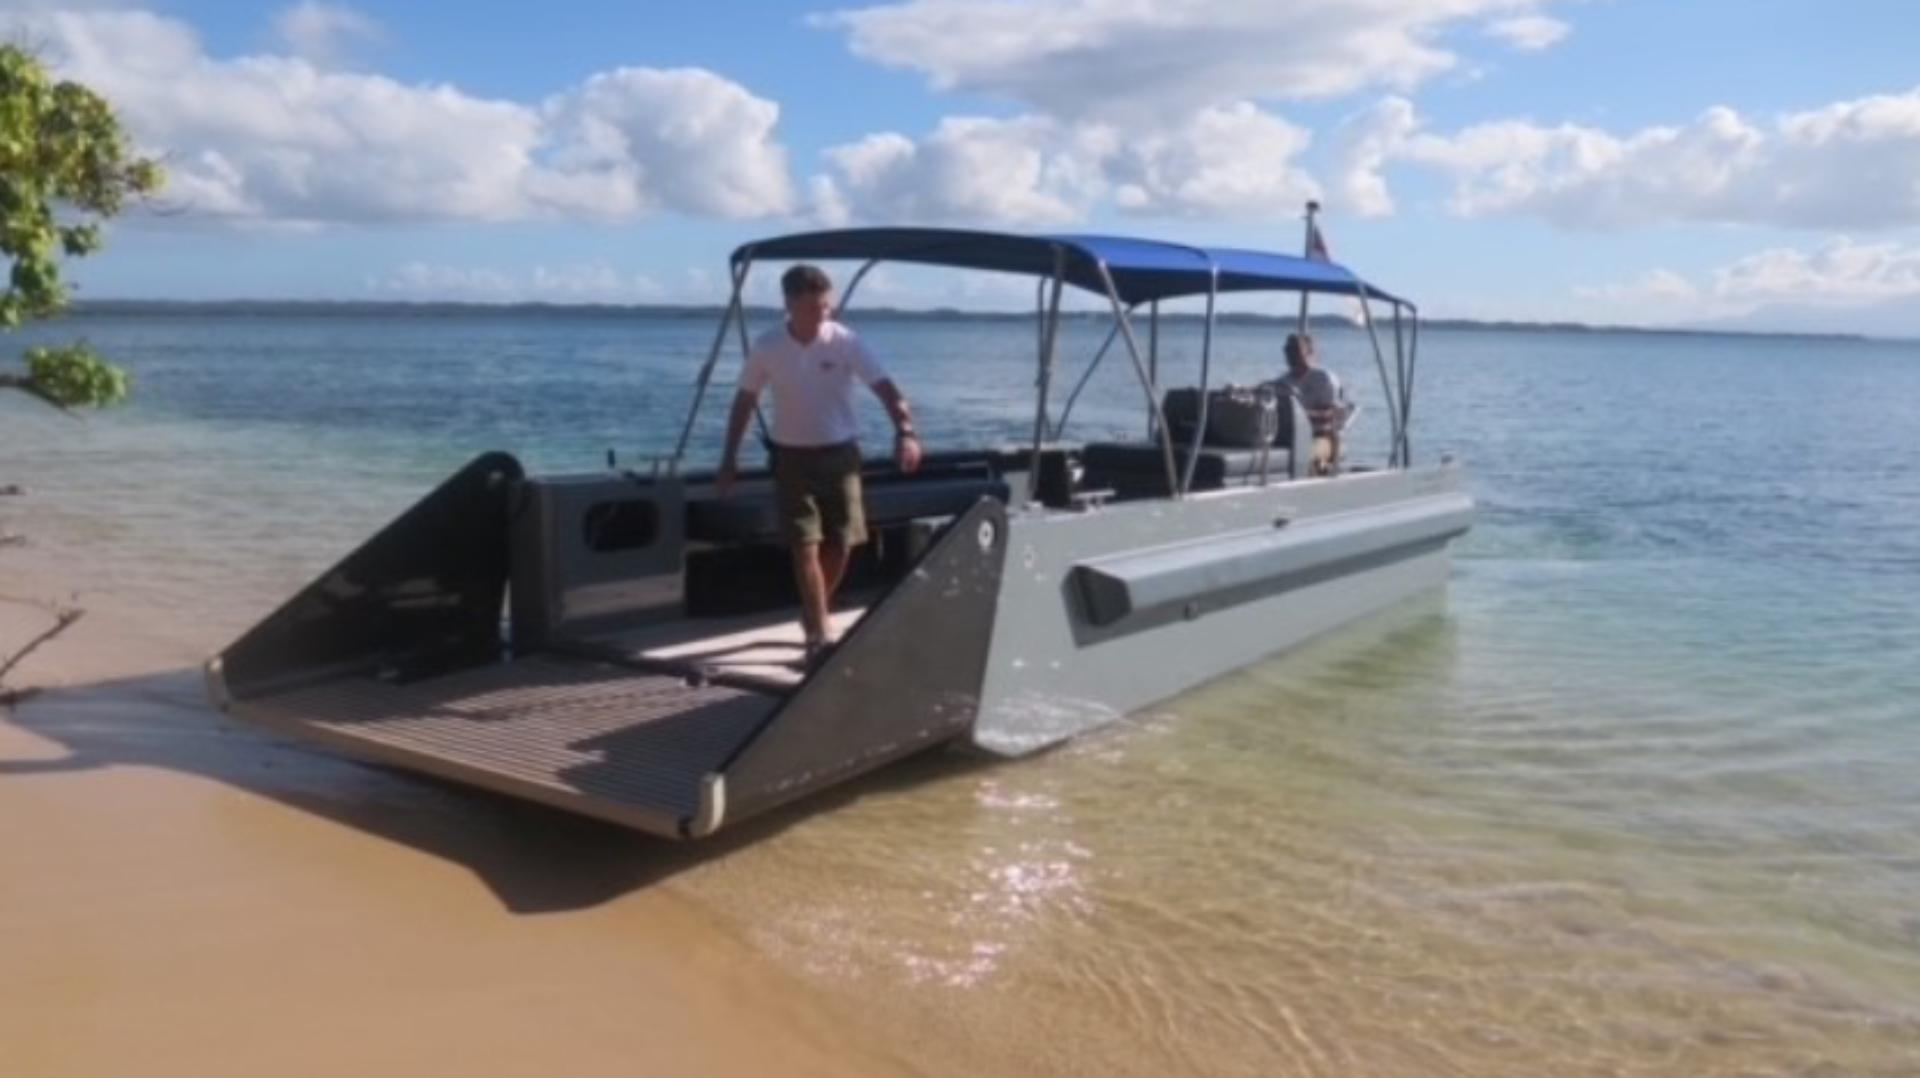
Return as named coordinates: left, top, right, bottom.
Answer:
left=714, top=265, right=920, bottom=667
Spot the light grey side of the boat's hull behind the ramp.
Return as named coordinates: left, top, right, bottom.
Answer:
left=970, top=457, right=1473, bottom=755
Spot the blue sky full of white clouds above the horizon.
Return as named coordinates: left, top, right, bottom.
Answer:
left=11, top=0, right=1920, bottom=334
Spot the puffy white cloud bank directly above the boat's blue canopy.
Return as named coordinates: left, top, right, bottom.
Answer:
left=812, top=102, right=1319, bottom=227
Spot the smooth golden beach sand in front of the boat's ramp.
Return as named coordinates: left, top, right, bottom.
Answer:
left=0, top=572, right=912, bottom=1078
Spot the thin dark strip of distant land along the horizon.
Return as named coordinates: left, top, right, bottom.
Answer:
left=48, top=300, right=1876, bottom=340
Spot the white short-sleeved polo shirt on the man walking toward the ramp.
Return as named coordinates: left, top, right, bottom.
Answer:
left=739, top=321, right=887, bottom=446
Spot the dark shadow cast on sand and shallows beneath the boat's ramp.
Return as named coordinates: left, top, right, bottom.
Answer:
left=0, top=669, right=993, bottom=913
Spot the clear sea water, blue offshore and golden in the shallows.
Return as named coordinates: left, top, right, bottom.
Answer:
left=0, top=313, right=1920, bottom=1074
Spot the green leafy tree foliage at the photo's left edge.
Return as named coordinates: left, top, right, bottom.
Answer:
left=0, top=44, right=163, bottom=407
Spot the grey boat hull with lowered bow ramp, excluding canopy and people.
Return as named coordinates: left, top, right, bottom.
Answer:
left=207, top=453, right=1473, bottom=838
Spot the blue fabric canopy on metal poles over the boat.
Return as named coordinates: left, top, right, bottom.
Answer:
left=733, top=229, right=1413, bottom=307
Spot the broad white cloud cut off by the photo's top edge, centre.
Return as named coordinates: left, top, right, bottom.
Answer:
left=816, top=0, right=1549, bottom=117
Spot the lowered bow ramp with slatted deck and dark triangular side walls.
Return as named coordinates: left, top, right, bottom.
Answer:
left=207, top=453, right=1006, bottom=838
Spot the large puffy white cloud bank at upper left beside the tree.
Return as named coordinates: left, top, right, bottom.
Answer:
left=12, top=12, right=793, bottom=223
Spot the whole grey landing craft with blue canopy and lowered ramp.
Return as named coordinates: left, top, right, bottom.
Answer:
left=207, top=229, right=1473, bottom=838
